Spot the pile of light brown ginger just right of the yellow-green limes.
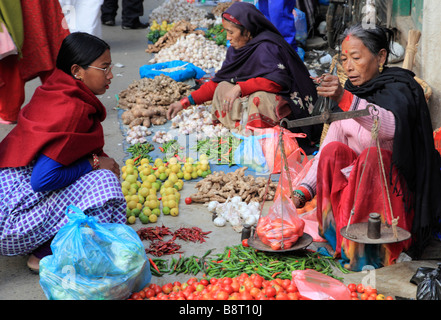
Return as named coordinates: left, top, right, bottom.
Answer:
left=190, top=167, right=277, bottom=203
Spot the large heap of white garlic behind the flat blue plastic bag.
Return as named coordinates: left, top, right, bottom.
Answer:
left=150, top=33, right=227, bottom=73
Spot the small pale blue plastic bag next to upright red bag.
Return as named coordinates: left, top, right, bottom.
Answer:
left=231, top=132, right=271, bottom=174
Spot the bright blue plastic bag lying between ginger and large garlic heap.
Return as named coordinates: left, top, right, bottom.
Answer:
left=139, top=60, right=206, bottom=81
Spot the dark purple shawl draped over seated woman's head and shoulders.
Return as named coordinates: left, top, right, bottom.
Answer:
left=213, top=2, right=317, bottom=103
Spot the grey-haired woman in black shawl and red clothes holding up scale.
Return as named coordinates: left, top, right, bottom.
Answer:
left=294, top=24, right=441, bottom=271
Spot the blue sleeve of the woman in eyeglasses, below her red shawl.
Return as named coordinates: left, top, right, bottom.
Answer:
left=31, top=154, right=92, bottom=192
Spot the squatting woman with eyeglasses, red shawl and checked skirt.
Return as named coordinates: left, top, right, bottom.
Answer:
left=0, top=32, right=126, bottom=271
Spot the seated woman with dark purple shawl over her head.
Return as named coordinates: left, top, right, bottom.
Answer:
left=168, top=2, right=322, bottom=152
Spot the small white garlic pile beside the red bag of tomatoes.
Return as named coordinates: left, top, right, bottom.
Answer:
left=207, top=196, right=260, bottom=232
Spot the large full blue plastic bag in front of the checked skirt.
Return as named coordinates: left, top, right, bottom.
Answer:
left=40, top=206, right=152, bottom=300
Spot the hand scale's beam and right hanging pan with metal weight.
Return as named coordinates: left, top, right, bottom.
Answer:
left=280, top=98, right=411, bottom=244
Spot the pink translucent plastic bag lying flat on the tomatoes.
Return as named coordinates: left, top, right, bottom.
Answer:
left=292, top=269, right=351, bottom=300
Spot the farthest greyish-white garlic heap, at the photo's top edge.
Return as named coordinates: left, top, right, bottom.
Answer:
left=149, top=0, right=213, bottom=28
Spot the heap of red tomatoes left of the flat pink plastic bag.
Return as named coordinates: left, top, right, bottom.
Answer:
left=129, top=273, right=306, bottom=300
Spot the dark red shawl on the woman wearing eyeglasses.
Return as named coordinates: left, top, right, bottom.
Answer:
left=0, top=69, right=106, bottom=168
